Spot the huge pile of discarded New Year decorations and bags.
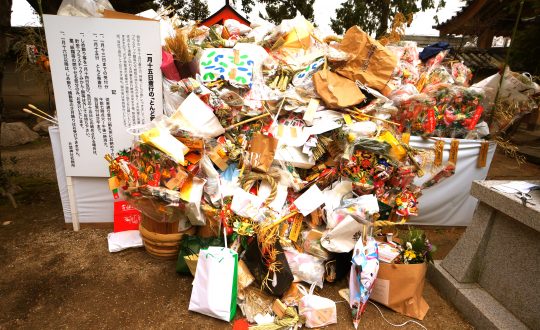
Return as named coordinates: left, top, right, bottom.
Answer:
left=108, top=12, right=537, bottom=329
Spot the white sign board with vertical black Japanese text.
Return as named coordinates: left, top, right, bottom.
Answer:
left=43, top=15, right=163, bottom=177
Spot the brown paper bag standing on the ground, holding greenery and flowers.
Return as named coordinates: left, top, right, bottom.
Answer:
left=370, top=262, right=429, bottom=320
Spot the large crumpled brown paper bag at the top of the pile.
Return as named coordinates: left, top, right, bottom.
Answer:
left=336, top=26, right=397, bottom=95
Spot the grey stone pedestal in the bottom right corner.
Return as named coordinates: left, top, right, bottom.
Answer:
left=428, top=181, right=540, bottom=329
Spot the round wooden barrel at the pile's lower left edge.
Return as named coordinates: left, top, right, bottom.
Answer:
left=139, top=215, right=196, bottom=259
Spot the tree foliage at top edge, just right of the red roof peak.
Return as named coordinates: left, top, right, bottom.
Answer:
left=233, top=0, right=315, bottom=24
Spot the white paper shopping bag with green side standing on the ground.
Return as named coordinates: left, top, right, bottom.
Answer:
left=189, top=246, right=238, bottom=322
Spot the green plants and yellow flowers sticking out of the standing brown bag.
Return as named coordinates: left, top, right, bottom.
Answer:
left=399, top=227, right=437, bottom=264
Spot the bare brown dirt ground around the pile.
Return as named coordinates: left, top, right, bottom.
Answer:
left=0, top=138, right=540, bottom=329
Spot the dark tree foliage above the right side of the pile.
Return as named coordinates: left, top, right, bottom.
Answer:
left=331, top=0, right=446, bottom=38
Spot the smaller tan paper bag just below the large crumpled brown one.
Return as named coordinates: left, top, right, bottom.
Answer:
left=313, top=70, right=366, bottom=109
